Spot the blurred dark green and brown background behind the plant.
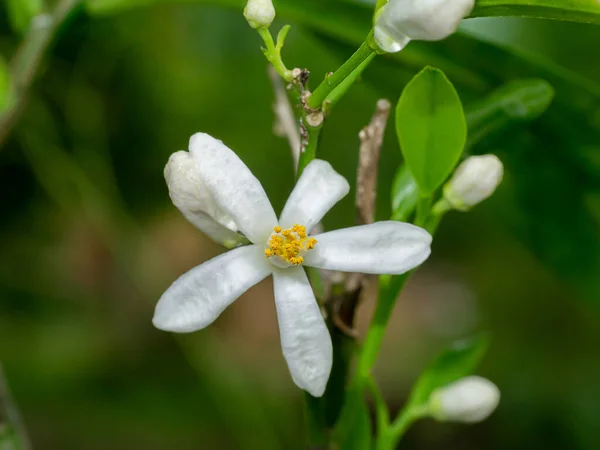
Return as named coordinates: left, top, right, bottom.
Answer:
left=0, top=0, right=600, bottom=450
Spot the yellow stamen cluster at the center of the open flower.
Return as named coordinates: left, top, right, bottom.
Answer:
left=265, top=225, right=317, bottom=267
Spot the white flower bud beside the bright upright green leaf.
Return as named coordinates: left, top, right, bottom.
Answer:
left=444, top=155, right=504, bottom=211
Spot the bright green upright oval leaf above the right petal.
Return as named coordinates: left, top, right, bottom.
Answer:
left=396, top=67, right=467, bottom=196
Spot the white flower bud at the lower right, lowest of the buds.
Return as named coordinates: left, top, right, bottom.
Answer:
left=429, top=376, right=500, bottom=423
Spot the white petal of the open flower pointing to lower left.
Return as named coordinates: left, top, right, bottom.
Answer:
left=152, top=245, right=272, bottom=333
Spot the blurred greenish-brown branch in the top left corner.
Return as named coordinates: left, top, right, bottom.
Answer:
left=0, top=0, right=82, bottom=144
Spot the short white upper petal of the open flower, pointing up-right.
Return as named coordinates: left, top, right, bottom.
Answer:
left=279, top=159, right=350, bottom=231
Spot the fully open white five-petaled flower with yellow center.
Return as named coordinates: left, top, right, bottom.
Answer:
left=153, top=133, right=431, bottom=396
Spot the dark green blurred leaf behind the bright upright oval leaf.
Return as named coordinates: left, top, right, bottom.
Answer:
left=465, top=79, right=554, bottom=149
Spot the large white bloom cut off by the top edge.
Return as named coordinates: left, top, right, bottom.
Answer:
left=375, top=0, right=475, bottom=53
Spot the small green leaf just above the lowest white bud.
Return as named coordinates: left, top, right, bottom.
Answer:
left=409, top=335, right=489, bottom=407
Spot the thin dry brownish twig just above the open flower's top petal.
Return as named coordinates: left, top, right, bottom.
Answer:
left=268, top=66, right=301, bottom=168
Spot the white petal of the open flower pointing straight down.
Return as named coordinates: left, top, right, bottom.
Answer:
left=273, top=267, right=333, bottom=397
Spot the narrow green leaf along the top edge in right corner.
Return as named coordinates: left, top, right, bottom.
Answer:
left=471, top=0, right=600, bottom=24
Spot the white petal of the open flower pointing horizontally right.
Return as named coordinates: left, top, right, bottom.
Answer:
left=304, top=221, right=431, bottom=274
